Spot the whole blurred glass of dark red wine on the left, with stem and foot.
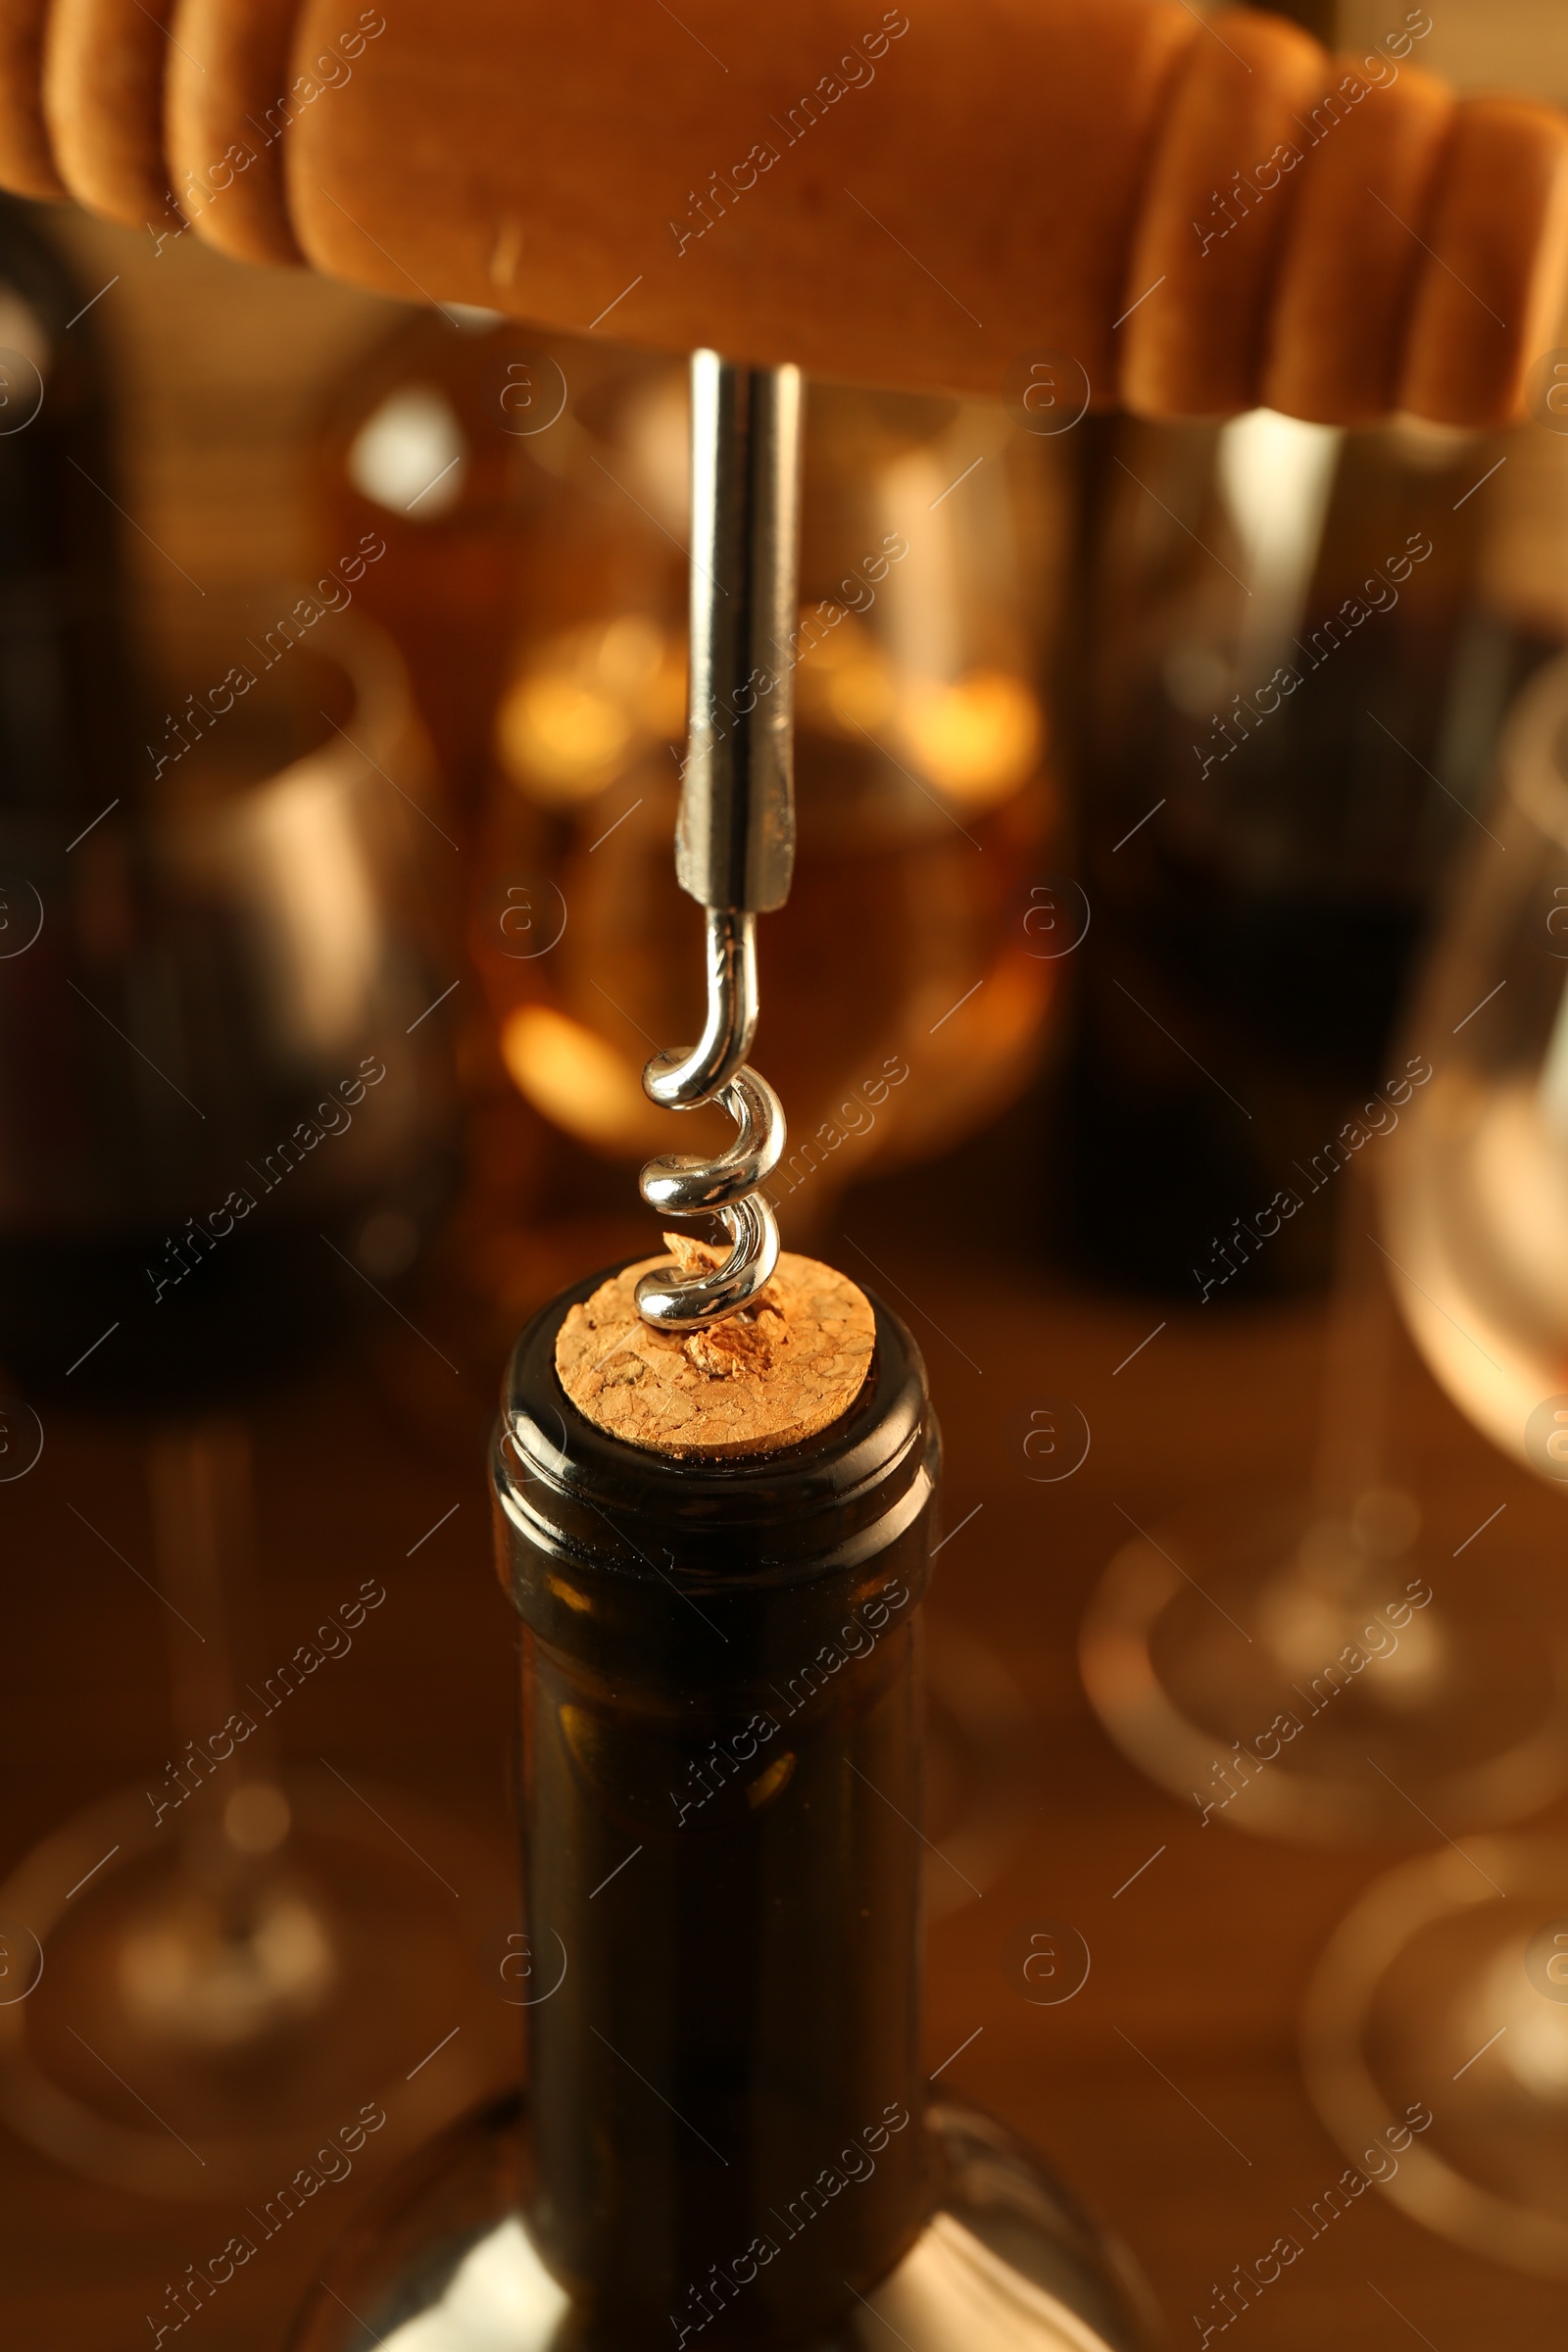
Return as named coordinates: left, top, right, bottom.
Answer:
left=0, top=615, right=510, bottom=2197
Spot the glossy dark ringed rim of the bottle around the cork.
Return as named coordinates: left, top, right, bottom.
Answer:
left=491, top=1260, right=941, bottom=1592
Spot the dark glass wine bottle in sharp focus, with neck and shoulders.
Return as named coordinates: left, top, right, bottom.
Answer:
left=294, top=1260, right=1145, bottom=2352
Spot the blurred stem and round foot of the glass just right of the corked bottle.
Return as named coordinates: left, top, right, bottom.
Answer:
left=1079, top=1161, right=1568, bottom=1846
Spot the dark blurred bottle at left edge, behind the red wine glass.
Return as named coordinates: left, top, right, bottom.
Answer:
left=0, top=198, right=134, bottom=816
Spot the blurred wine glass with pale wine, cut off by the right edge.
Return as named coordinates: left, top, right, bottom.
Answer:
left=1304, top=661, right=1568, bottom=2279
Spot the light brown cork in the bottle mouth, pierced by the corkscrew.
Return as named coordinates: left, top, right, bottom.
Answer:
left=555, top=1233, right=877, bottom=1460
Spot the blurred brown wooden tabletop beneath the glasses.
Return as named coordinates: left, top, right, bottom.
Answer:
left=0, top=1195, right=1563, bottom=2352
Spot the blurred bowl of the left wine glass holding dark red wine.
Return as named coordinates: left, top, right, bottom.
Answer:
left=0, top=621, right=456, bottom=1409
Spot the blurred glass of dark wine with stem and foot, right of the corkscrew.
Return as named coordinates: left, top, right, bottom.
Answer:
left=1079, top=410, right=1568, bottom=1844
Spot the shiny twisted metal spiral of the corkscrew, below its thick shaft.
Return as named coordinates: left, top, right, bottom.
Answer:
left=637, top=910, right=785, bottom=1331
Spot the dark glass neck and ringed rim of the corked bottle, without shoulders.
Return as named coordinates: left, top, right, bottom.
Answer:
left=494, top=1282, right=938, bottom=2347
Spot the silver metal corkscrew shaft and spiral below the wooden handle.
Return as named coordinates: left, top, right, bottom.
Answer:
left=637, top=351, right=802, bottom=1331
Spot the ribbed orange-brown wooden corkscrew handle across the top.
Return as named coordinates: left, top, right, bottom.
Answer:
left=0, top=0, right=1568, bottom=425
